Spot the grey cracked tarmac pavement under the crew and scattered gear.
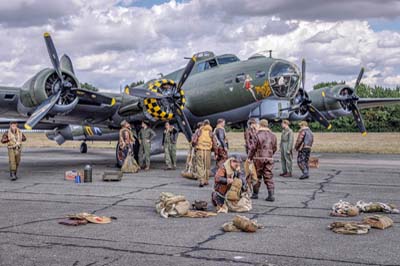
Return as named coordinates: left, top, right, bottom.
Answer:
left=0, top=148, right=400, bottom=266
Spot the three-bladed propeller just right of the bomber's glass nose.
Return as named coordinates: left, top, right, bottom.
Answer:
left=281, top=58, right=332, bottom=129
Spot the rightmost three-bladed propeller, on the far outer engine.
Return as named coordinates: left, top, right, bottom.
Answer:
left=322, top=68, right=367, bottom=136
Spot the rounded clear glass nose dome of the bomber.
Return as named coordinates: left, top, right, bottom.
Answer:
left=269, top=61, right=300, bottom=97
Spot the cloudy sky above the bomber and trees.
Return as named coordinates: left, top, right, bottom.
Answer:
left=0, top=0, right=400, bottom=91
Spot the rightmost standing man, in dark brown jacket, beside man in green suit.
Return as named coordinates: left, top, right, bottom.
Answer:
left=295, top=121, right=314, bottom=179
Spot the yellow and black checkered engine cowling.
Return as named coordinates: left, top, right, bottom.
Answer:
left=144, top=79, right=186, bottom=121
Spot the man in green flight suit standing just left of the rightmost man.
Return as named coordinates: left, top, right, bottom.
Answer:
left=280, top=120, right=294, bottom=177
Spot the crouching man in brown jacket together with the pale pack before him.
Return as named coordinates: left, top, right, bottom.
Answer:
left=211, top=156, right=251, bottom=211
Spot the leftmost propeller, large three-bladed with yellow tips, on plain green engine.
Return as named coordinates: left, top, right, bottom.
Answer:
left=25, top=32, right=116, bottom=129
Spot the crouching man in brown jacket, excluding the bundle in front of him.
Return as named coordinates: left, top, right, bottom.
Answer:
left=211, top=156, right=246, bottom=209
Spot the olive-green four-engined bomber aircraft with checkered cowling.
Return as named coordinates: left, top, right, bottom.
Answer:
left=0, top=33, right=400, bottom=163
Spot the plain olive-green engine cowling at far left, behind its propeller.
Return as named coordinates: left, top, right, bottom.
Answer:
left=18, top=68, right=79, bottom=116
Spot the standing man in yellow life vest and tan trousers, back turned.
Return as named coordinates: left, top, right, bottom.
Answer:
left=192, top=120, right=214, bottom=187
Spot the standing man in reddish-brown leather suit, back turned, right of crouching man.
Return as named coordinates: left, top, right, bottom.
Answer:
left=248, top=119, right=277, bottom=201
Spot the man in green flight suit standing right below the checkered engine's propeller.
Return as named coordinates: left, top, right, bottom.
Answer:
left=162, top=122, right=178, bottom=170
